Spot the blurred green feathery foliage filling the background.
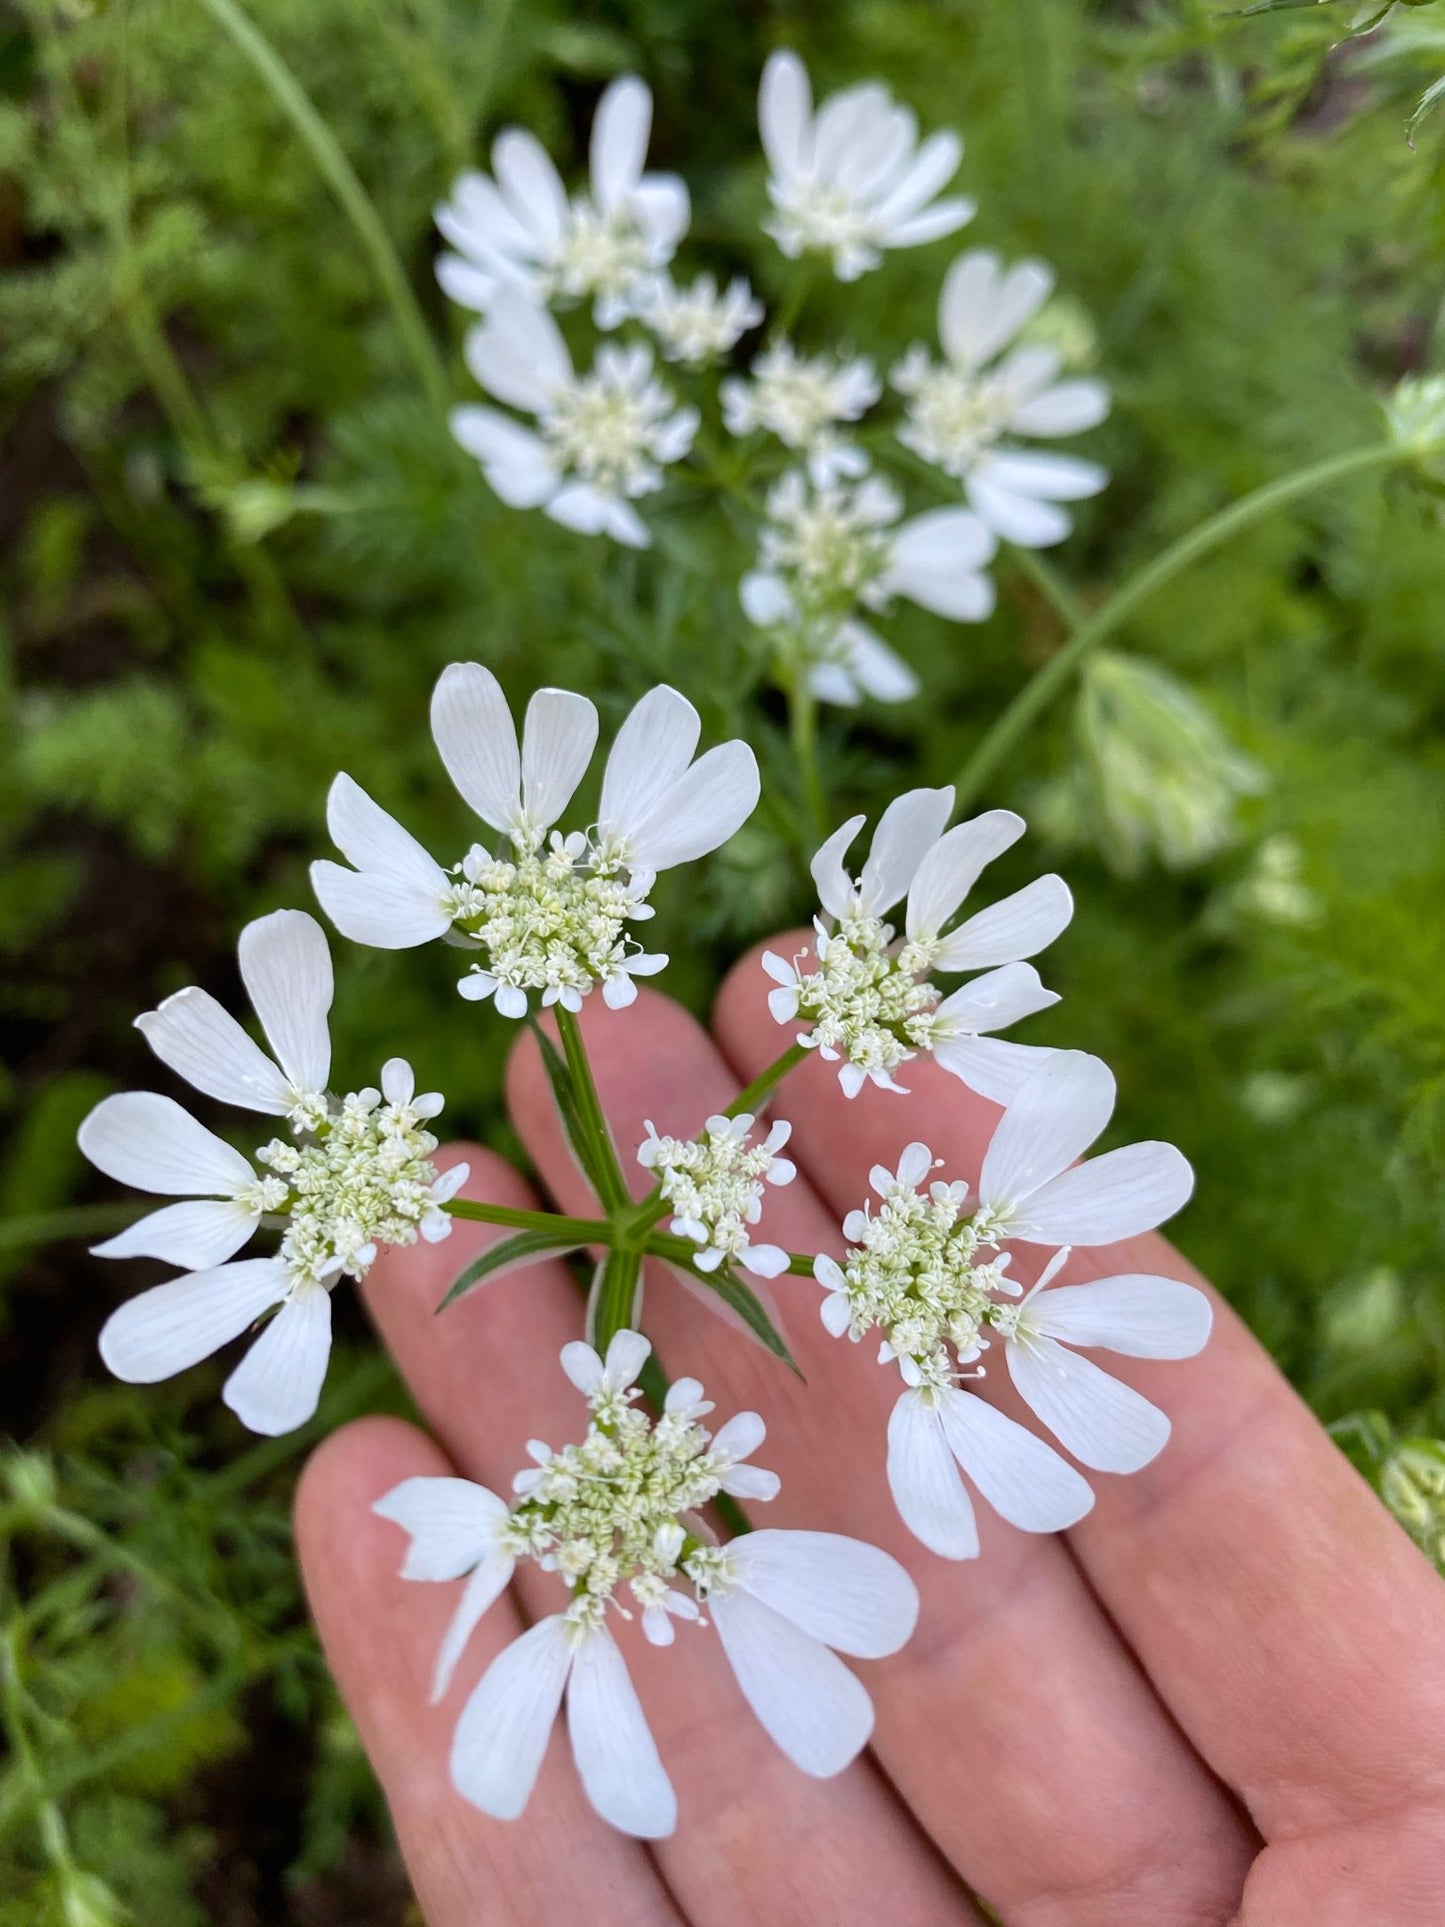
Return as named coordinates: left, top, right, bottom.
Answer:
left=0, top=0, right=1445, bottom=1927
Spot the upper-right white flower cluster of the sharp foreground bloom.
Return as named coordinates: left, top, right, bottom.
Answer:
left=763, top=786, right=1073, bottom=1104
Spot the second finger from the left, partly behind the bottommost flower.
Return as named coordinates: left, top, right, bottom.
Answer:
left=366, top=1150, right=977, bottom=1927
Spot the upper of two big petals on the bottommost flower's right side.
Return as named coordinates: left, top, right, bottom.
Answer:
left=730, top=1532, right=919, bottom=1659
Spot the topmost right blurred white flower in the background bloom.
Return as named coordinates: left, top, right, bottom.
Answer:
left=757, top=52, right=973, bottom=281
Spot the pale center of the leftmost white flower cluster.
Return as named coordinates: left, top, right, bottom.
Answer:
left=256, top=1091, right=437, bottom=1285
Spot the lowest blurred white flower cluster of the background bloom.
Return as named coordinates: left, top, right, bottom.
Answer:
left=738, top=468, right=998, bottom=703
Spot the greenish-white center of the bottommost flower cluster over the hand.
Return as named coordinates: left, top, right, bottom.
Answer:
left=505, top=1387, right=726, bottom=1630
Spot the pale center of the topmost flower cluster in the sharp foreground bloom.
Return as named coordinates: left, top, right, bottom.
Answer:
left=453, top=834, right=651, bottom=994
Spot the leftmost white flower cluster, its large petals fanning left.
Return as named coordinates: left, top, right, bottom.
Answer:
left=79, top=910, right=466, bottom=1434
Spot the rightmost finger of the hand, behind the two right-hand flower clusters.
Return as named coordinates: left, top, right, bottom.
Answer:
left=719, top=940, right=1445, bottom=1840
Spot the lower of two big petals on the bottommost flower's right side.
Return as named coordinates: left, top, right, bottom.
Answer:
left=709, top=1590, right=873, bottom=1779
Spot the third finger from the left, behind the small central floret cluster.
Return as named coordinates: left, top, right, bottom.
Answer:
left=509, top=994, right=1252, bottom=1927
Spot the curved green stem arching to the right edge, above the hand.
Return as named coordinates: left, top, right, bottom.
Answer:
left=956, top=441, right=1420, bottom=809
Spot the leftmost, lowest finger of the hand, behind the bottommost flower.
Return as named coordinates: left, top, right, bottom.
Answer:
left=297, top=1418, right=678, bottom=1927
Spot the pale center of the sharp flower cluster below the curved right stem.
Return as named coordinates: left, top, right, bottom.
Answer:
left=798, top=915, right=940, bottom=1071
